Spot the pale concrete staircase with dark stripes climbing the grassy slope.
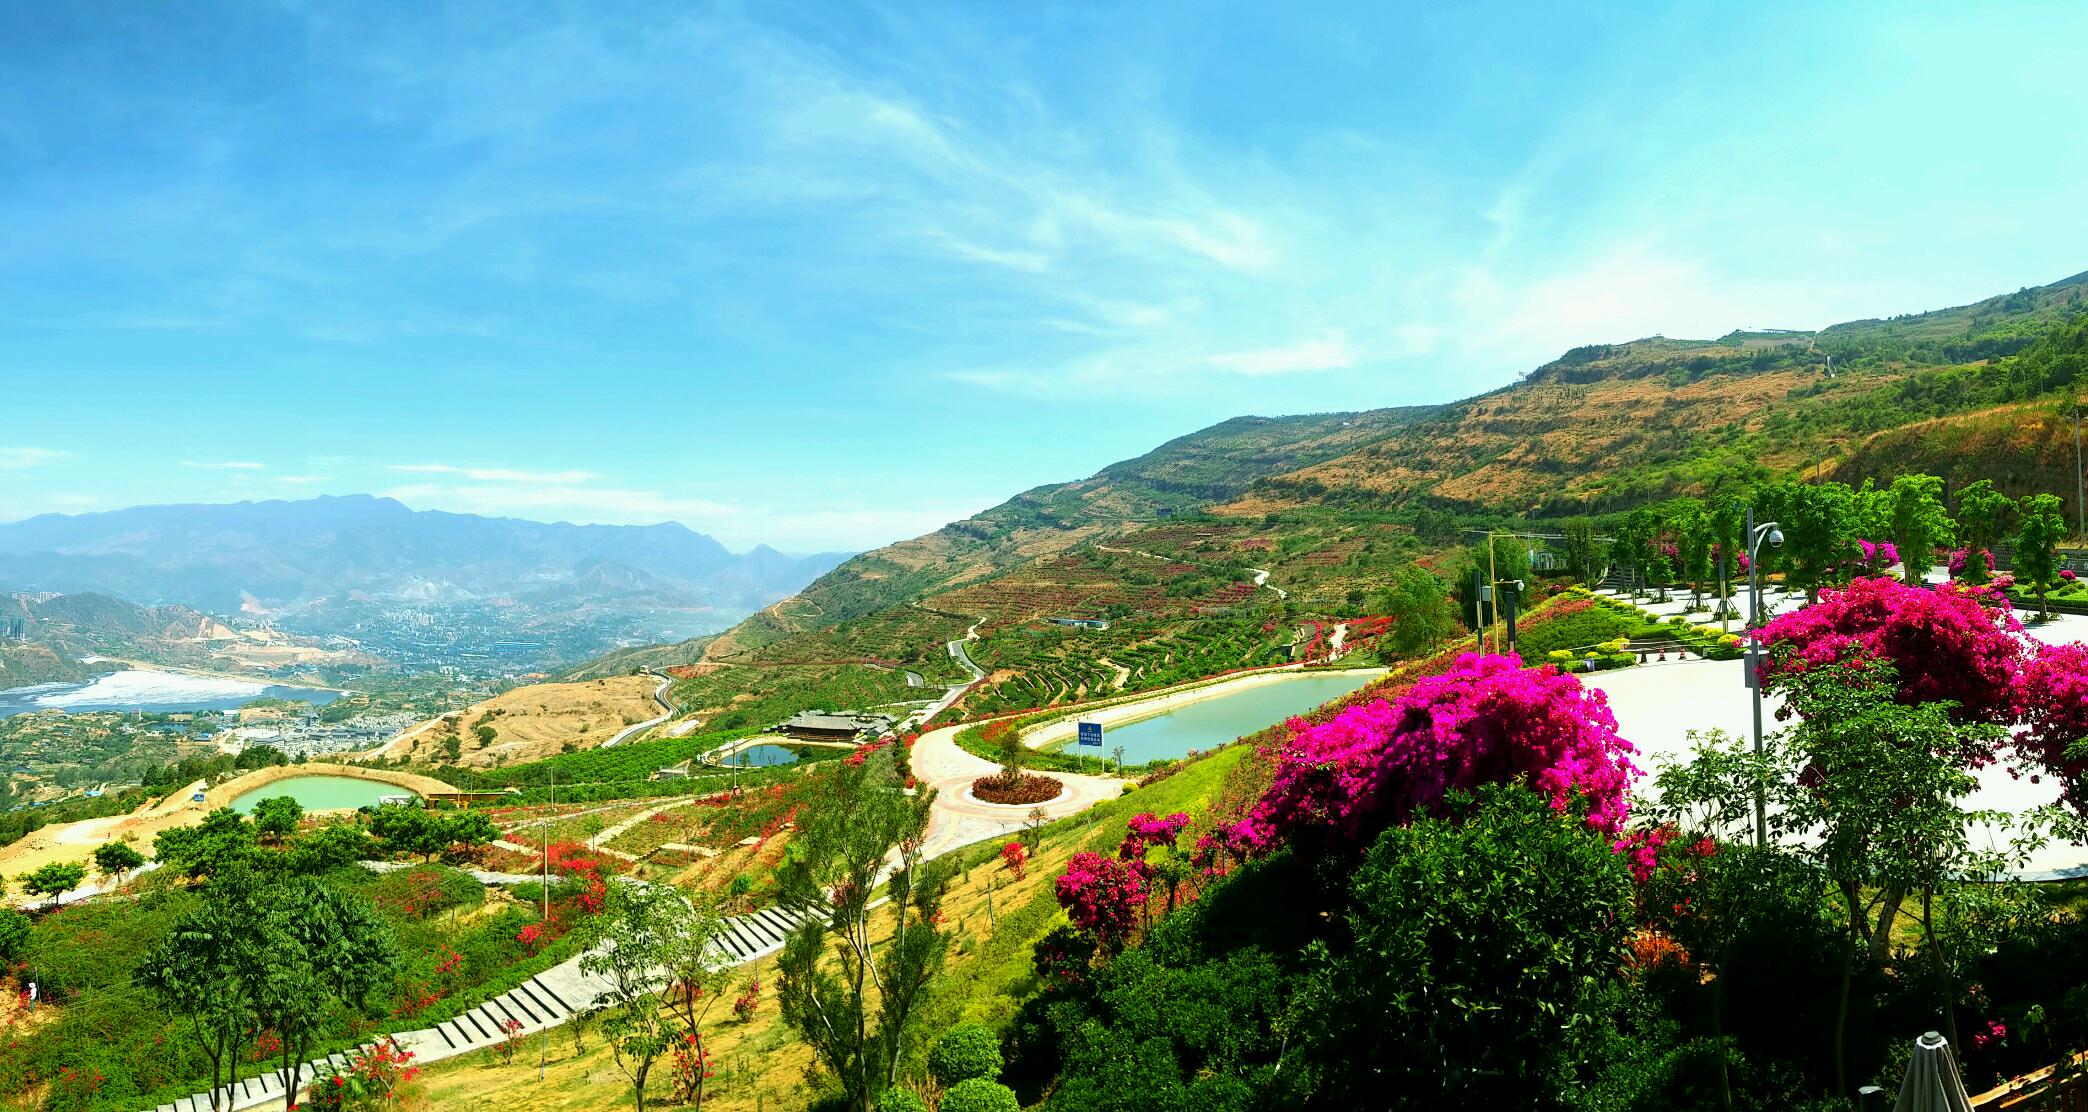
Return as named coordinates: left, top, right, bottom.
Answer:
left=155, top=908, right=825, bottom=1112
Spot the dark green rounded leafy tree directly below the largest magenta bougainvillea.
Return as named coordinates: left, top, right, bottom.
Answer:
left=1297, top=787, right=1633, bottom=1108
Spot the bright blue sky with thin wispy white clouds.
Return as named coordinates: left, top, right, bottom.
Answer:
left=0, top=0, right=2088, bottom=551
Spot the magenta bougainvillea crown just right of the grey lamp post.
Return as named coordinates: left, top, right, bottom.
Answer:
left=1756, top=576, right=2025, bottom=730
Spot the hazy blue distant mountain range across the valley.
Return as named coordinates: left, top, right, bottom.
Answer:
left=0, top=494, right=846, bottom=667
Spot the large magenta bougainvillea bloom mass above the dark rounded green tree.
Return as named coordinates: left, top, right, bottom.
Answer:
left=1224, top=653, right=1639, bottom=855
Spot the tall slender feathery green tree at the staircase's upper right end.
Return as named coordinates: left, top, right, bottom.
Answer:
left=777, top=747, right=950, bottom=1112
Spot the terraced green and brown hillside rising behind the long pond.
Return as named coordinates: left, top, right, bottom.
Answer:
left=605, top=273, right=2088, bottom=726
